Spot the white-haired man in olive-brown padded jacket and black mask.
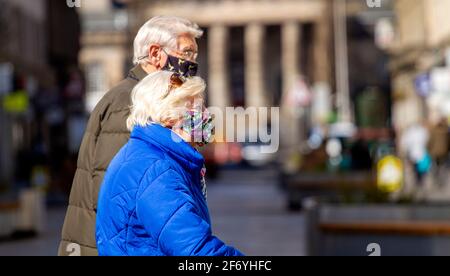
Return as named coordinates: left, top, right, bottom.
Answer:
left=58, top=16, right=203, bottom=256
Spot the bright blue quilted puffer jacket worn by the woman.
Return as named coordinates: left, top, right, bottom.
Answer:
left=96, top=124, right=241, bottom=256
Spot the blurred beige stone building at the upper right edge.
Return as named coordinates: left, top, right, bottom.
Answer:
left=389, top=0, right=450, bottom=132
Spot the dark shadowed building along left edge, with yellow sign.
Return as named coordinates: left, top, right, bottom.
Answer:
left=0, top=0, right=80, bottom=198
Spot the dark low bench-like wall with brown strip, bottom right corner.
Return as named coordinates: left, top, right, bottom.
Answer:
left=305, top=201, right=450, bottom=256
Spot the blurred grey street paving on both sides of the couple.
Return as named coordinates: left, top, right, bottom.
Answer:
left=0, top=167, right=306, bottom=256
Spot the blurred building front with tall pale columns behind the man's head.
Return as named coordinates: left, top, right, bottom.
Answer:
left=131, top=0, right=333, bottom=110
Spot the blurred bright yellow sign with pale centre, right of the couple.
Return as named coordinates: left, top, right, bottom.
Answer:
left=377, top=155, right=403, bottom=193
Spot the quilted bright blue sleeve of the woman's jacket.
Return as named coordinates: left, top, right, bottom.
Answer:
left=136, top=165, right=242, bottom=256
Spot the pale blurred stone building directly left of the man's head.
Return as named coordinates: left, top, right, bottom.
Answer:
left=78, top=0, right=132, bottom=112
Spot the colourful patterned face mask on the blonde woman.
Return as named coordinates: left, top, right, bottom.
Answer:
left=181, top=109, right=214, bottom=147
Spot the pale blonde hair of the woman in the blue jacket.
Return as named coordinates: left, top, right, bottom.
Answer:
left=127, top=71, right=206, bottom=131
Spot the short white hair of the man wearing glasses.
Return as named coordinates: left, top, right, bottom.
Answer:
left=133, top=16, right=203, bottom=65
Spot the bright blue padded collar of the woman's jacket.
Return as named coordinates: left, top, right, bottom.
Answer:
left=131, top=124, right=204, bottom=176
